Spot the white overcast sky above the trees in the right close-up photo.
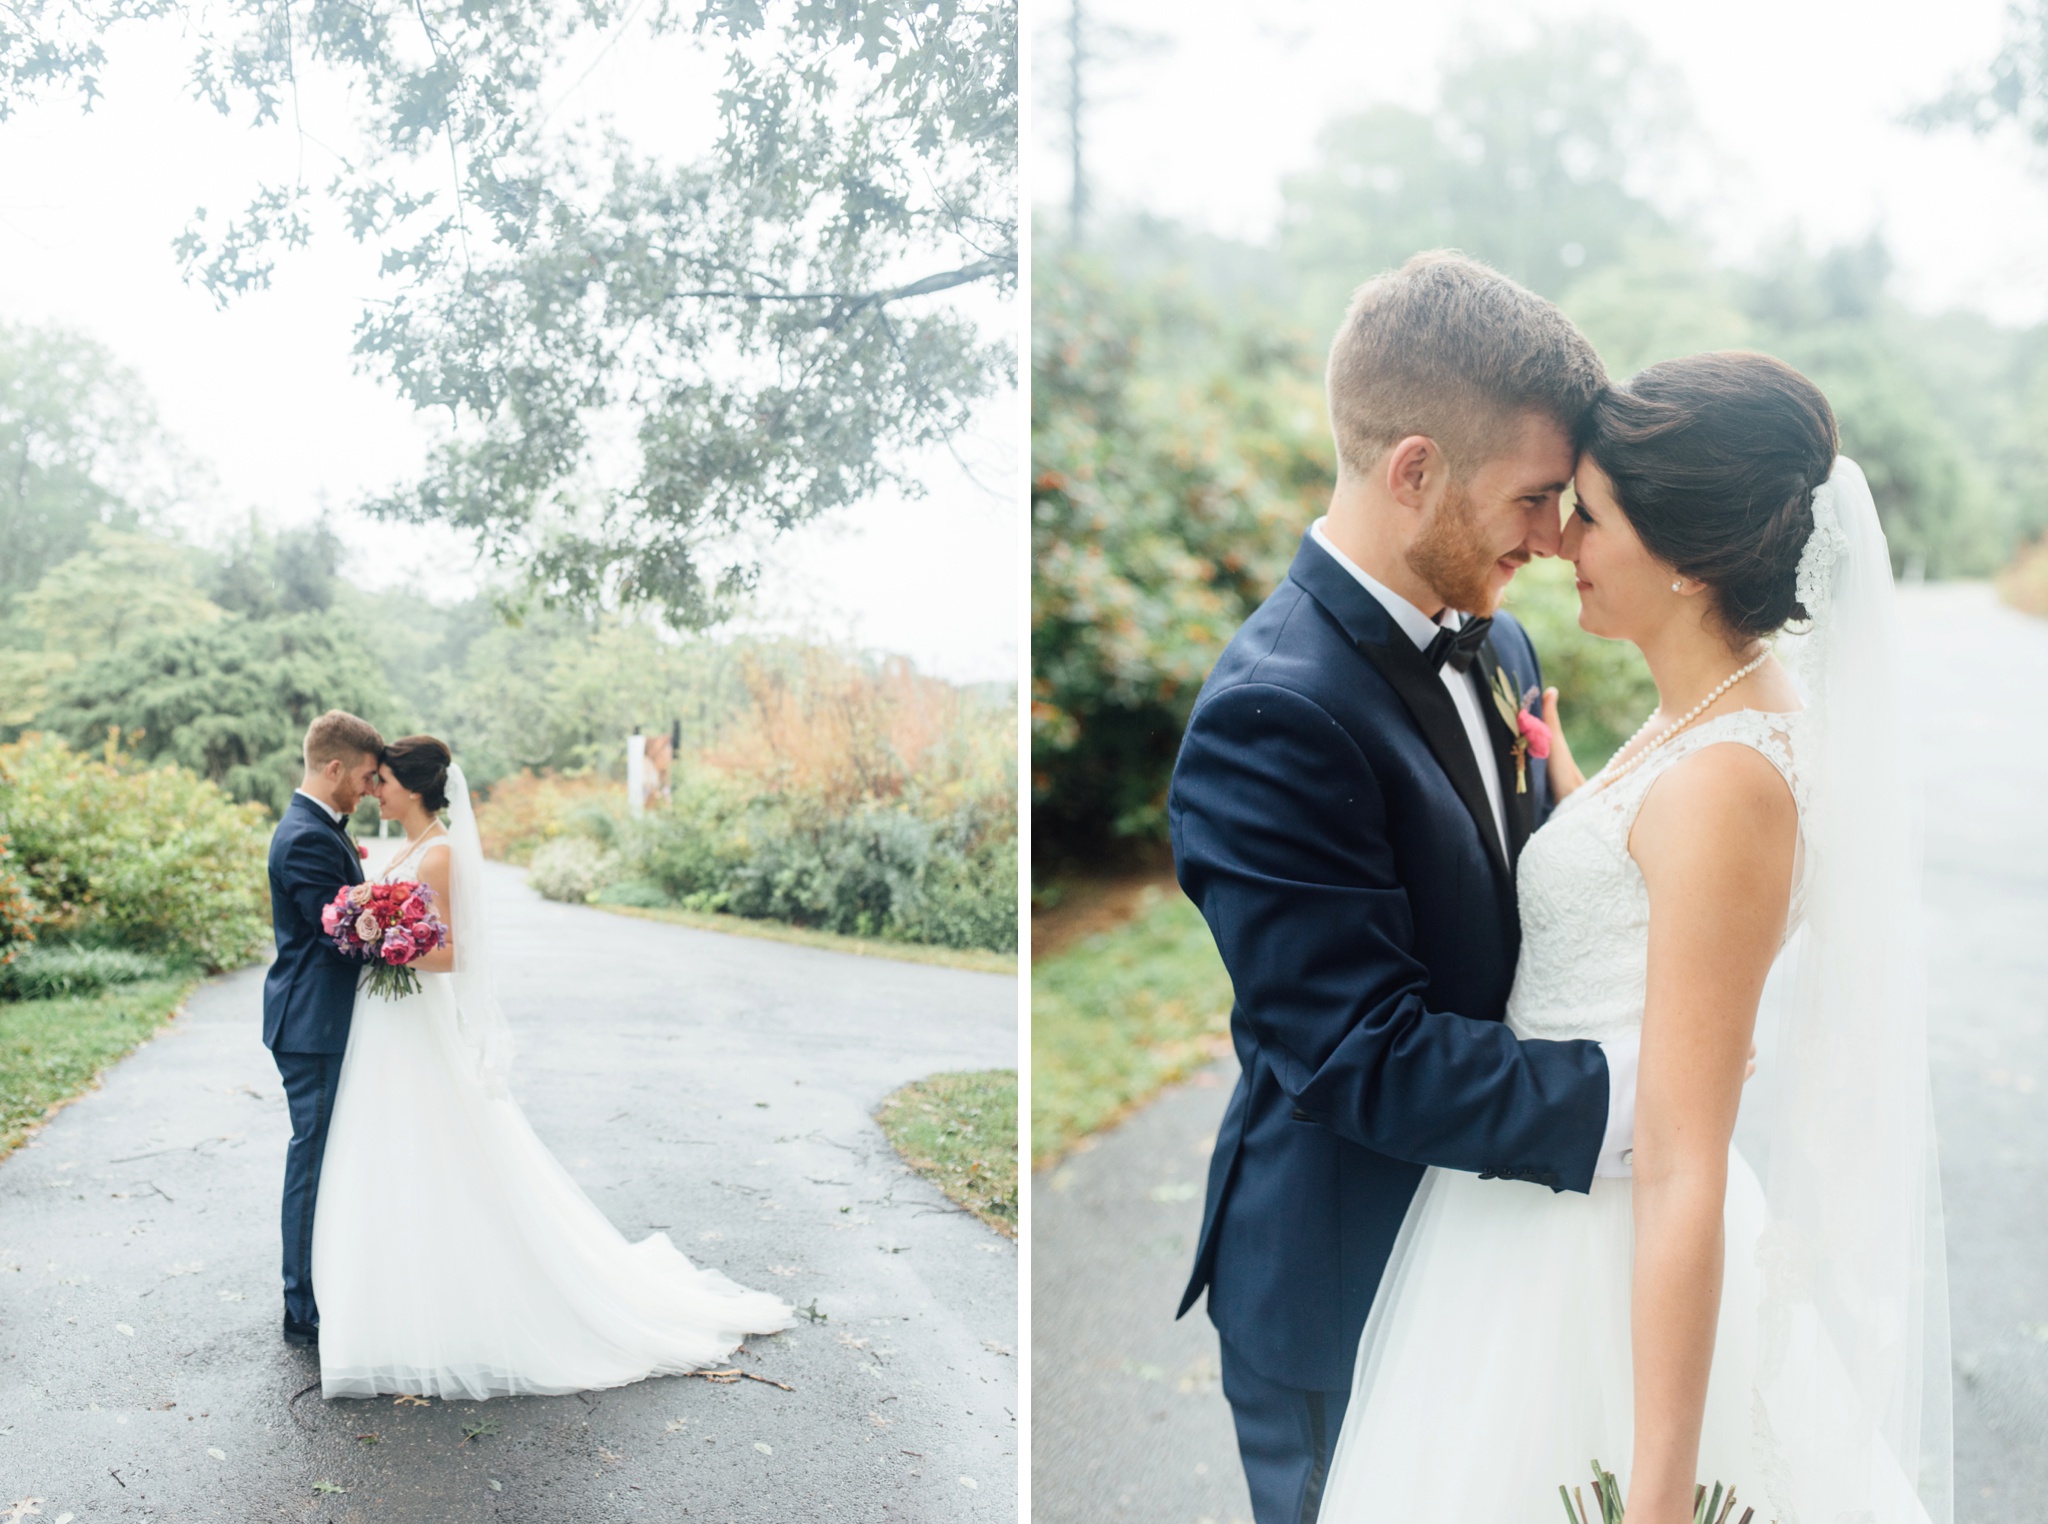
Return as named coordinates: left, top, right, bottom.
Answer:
left=1032, top=0, right=2048, bottom=322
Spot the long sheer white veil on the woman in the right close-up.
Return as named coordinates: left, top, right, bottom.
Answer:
left=1739, top=457, right=1954, bottom=1524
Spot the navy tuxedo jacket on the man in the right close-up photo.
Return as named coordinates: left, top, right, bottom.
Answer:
left=1167, top=537, right=1608, bottom=1391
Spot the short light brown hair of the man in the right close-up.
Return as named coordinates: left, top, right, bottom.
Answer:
left=1325, top=250, right=1608, bottom=475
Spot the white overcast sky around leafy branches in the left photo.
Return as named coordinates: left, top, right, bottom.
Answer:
left=0, top=25, right=1022, bottom=680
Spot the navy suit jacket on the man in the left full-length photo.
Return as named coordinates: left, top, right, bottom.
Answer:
left=262, top=793, right=362, bottom=1053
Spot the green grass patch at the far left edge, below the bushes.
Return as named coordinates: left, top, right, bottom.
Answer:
left=0, top=977, right=199, bottom=1157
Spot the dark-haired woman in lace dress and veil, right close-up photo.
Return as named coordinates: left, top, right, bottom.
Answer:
left=1321, top=354, right=1952, bottom=1524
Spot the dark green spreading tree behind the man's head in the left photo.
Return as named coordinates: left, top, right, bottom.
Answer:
left=37, top=615, right=393, bottom=811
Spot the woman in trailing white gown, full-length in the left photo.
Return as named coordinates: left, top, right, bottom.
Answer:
left=313, top=735, right=791, bottom=1399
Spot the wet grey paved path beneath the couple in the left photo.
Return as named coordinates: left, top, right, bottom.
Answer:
left=0, top=871, right=1018, bottom=1524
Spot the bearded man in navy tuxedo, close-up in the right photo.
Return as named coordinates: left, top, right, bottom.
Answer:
left=1169, top=254, right=1634, bottom=1524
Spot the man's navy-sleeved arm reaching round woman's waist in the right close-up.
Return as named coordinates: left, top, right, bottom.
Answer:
left=1171, top=684, right=1608, bottom=1190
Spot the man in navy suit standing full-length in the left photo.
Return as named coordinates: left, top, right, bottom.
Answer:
left=262, top=709, right=383, bottom=1346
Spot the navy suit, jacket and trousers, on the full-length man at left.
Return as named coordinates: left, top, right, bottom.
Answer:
left=262, top=793, right=362, bottom=1325
